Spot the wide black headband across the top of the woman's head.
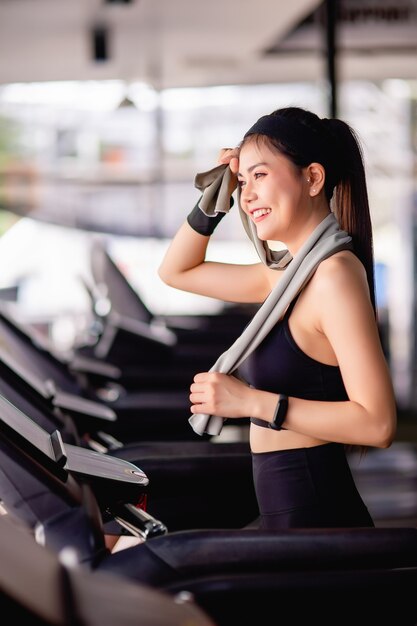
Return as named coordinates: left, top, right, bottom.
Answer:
left=244, top=115, right=331, bottom=167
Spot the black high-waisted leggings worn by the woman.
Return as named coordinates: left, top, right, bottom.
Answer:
left=252, top=443, right=374, bottom=530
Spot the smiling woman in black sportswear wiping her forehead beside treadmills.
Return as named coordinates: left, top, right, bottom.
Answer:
left=159, top=107, right=396, bottom=529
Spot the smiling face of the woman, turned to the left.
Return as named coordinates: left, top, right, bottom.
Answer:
left=238, top=141, right=309, bottom=242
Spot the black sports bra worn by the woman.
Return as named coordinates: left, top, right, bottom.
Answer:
left=238, top=296, right=348, bottom=423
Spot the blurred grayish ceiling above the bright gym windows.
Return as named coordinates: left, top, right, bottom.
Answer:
left=0, top=0, right=417, bottom=88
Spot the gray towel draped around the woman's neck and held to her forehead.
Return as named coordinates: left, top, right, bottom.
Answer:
left=189, top=166, right=352, bottom=435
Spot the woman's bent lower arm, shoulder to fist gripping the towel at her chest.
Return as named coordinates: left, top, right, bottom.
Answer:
left=190, top=255, right=397, bottom=449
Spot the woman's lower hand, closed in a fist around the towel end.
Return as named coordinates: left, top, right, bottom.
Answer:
left=190, top=372, right=250, bottom=418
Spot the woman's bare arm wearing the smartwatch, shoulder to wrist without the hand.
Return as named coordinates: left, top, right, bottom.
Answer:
left=253, top=254, right=397, bottom=448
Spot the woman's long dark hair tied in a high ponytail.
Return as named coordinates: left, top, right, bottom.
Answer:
left=241, top=107, right=376, bottom=312
